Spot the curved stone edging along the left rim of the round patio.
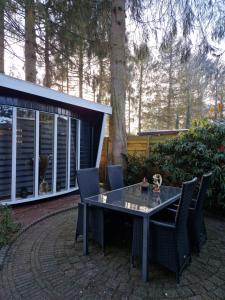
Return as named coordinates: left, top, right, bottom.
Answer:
left=0, top=204, right=78, bottom=271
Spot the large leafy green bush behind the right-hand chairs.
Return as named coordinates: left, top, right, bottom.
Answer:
left=146, top=120, right=225, bottom=211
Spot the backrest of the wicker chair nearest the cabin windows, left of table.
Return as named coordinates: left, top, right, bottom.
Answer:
left=77, top=168, right=100, bottom=202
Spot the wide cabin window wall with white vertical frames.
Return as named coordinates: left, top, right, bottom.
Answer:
left=0, top=105, right=79, bottom=203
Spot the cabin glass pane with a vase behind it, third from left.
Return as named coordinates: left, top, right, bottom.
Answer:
left=39, top=112, right=54, bottom=194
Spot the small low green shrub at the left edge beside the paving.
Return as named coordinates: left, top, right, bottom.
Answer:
left=0, top=205, right=19, bottom=248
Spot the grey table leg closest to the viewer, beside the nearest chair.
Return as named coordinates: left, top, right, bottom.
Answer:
left=142, top=217, right=149, bottom=282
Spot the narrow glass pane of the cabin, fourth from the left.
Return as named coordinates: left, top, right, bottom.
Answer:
left=56, top=116, right=67, bottom=192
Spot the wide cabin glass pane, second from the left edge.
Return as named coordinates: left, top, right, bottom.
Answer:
left=16, top=108, right=35, bottom=198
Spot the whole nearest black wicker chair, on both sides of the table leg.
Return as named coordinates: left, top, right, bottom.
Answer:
left=132, top=178, right=197, bottom=284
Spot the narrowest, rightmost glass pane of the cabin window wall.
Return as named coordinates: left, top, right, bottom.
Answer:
left=70, top=119, right=77, bottom=188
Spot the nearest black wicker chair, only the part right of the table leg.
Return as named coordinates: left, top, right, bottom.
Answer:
left=150, top=178, right=197, bottom=284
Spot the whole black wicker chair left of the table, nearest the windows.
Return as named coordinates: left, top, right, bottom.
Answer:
left=75, top=168, right=104, bottom=251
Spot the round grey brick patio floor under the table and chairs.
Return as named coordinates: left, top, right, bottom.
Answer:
left=0, top=204, right=225, bottom=300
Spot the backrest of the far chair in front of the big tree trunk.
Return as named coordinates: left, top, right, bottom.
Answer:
left=106, top=165, right=124, bottom=191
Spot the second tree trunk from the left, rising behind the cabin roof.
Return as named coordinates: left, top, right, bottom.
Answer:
left=25, top=0, right=37, bottom=83
